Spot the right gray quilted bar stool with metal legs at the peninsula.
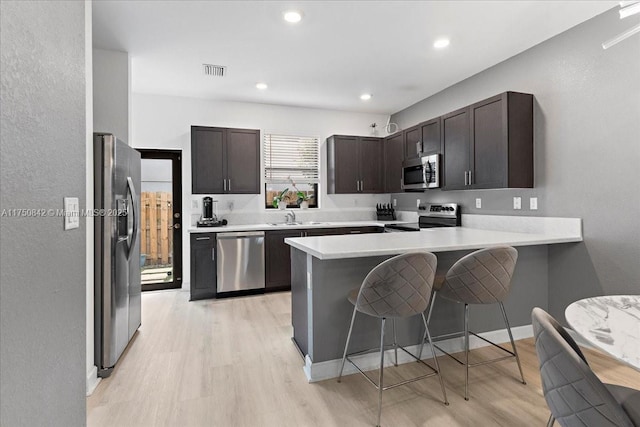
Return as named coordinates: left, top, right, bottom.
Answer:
left=420, top=246, right=526, bottom=400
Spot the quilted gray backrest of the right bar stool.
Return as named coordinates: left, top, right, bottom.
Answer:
left=438, top=246, right=518, bottom=304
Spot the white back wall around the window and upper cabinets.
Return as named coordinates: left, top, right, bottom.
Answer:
left=130, top=93, right=389, bottom=287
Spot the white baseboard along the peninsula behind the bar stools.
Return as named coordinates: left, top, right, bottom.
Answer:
left=303, top=325, right=533, bottom=383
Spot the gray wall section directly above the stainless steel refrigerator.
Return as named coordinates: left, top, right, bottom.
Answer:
left=93, top=49, right=131, bottom=145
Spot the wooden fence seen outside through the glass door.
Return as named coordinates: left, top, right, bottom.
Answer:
left=140, top=191, right=173, bottom=266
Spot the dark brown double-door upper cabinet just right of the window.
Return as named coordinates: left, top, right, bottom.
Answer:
left=327, top=135, right=384, bottom=194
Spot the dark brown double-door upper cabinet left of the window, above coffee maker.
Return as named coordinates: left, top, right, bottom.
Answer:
left=191, top=126, right=260, bottom=194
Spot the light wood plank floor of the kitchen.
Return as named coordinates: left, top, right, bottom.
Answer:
left=87, top=291, right=640, bottom=427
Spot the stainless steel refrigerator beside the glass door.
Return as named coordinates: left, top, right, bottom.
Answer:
left=93, top=133, right=141, bottom=377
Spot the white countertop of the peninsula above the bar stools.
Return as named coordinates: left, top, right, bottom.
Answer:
left=285, top=227, right=582, bottom=259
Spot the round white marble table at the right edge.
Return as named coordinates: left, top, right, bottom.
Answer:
left=564, top=295, right=640, bottom=370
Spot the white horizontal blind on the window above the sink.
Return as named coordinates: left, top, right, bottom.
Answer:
left=264, top=134, right=320, bottom=184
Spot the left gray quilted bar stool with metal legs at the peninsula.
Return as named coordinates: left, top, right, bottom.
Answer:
left=338, top=252, right=449, bottom=426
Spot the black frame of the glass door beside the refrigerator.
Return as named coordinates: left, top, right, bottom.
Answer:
left=137, top=148, right=184, bottom=291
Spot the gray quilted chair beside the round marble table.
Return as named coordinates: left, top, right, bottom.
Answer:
left=531, top=307, right=640, bottom=427
